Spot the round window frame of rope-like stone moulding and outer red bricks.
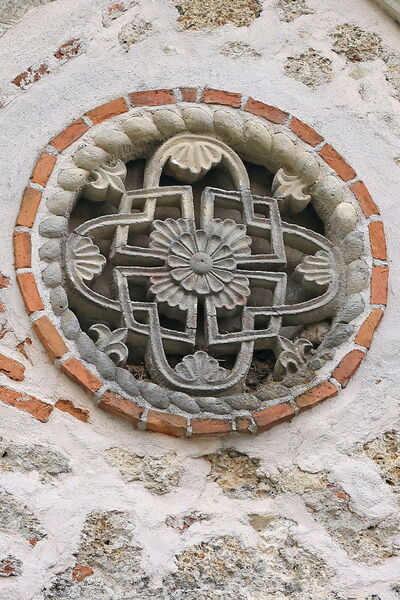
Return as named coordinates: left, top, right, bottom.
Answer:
left=14, top=88, right=388, bottom=437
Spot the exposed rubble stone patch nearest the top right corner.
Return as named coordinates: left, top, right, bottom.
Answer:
left=330, top=23, right=383, bottom=62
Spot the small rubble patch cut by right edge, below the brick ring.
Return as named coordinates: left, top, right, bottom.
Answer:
left=364, top=431, right=400, bottom=494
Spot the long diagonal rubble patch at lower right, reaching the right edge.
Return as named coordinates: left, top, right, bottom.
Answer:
left=269, top=467, right=400, bottom=565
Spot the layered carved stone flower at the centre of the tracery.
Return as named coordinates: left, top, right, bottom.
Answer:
left=150, top=219, right=251, bottom=310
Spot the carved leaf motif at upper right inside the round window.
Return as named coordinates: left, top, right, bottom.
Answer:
left=272, top=169, right=311, bottom=214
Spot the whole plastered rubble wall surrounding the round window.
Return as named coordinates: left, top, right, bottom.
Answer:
left=0, top=0, right=400, bottom=600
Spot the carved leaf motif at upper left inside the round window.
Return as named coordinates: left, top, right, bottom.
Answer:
left=83, top=160, right=126, bottom=202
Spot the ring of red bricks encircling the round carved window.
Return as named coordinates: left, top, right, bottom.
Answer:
left=11, top=88, right=388, bottom=437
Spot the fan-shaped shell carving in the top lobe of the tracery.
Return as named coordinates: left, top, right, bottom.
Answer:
left=167, top=140, right=222, bottom=183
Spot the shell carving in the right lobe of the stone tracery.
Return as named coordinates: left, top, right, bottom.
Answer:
left=295, top=250, right=335, bottom=293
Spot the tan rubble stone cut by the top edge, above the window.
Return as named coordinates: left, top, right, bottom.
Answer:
left=175, top=0, right=262, bottom=29
